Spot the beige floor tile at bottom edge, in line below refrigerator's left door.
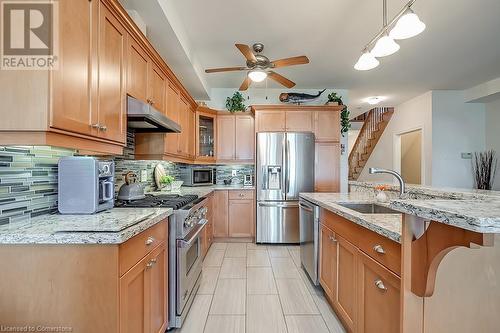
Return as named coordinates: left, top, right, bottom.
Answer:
left=246, top=295, right=286, bottom=333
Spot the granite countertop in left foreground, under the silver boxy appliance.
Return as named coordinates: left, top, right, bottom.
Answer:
left=0, top=208, right=173, bottom=244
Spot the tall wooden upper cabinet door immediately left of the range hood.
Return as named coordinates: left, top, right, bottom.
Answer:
left=97, top=2, right=127, bottom=143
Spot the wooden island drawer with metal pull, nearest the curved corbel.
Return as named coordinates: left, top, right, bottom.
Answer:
left=358, top=228, right=401, bottom=275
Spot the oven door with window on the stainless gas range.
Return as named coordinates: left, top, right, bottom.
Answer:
left=176, top=223, right=205, bottom=316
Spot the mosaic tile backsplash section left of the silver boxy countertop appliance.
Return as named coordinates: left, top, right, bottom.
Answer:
left=0, top=146, right=75, bottom=224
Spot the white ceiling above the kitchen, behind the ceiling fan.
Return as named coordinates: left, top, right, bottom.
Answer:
left=123, top=0, right=500, bottom=108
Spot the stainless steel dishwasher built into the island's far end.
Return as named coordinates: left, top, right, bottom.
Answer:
left=299, top=198, right=319, bottom=286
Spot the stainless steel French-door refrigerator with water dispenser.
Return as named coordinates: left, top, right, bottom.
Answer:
left=255, top=133, right=314, bottom=243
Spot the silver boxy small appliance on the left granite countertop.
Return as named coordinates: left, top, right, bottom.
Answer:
left=57, top=156, right=115, bottom=214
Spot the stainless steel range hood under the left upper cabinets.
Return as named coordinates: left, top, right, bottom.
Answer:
left=127, top=96, right=181, bottom=133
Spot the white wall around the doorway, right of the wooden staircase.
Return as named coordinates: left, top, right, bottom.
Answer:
left=358, top=91, right=432, bottom=185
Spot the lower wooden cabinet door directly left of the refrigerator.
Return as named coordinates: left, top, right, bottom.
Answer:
left=229, top=200, right=254, bottom=237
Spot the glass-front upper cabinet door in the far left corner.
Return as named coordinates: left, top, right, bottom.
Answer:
left=196, top=106, right=217, bottom=162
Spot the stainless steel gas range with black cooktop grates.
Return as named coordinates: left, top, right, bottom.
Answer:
left=116, top=194, right=208, bottom=329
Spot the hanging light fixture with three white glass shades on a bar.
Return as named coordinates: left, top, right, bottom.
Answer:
left=354, top=0, right=425, bottom=70
